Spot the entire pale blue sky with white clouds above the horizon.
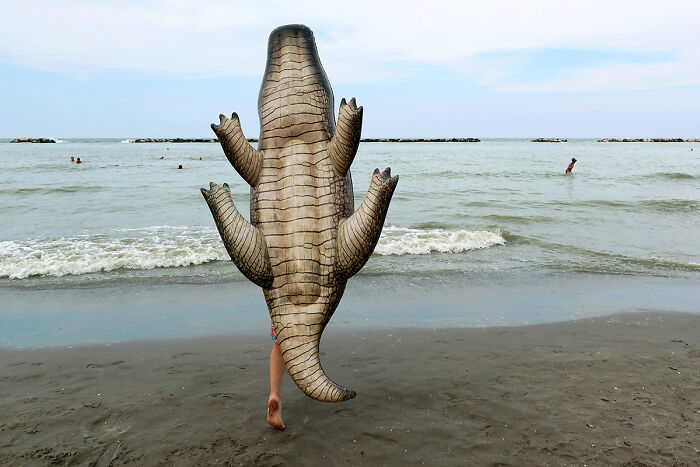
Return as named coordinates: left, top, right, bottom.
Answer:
left=0, top=0, right=700, bottom=138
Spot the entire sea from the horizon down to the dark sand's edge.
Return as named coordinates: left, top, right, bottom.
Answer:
left=0, top=138, right=700, bottom=346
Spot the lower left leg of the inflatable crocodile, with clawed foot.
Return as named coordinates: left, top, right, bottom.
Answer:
left=202, top=182, right=273, bottom=288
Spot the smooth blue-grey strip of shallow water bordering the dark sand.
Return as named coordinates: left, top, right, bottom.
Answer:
left=0, top=274, right=700, bottom=349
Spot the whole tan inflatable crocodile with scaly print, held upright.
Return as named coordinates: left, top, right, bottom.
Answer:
left=202, top=25, right=398, bottom=402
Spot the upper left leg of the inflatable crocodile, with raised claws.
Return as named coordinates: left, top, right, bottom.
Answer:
left=211, top=112, right=262, bottom=186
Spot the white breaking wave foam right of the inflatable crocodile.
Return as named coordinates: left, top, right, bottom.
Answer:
left=374, top=226, right=506, bottom=256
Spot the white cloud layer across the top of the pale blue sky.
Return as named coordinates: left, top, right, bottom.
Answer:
left=0, top=0, right=700, bottom=92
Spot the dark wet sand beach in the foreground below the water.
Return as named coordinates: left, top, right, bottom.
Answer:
left=0, top=313, right=700, bottom=466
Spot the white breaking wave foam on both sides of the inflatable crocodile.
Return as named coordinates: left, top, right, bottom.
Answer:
left=0, top=226, right=505, bottom=279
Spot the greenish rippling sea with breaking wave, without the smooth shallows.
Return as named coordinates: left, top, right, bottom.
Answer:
left=0, top=139, right=700, bottom=348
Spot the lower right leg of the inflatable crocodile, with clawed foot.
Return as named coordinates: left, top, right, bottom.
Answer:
left=335, top=168, right=399, bottom=279
